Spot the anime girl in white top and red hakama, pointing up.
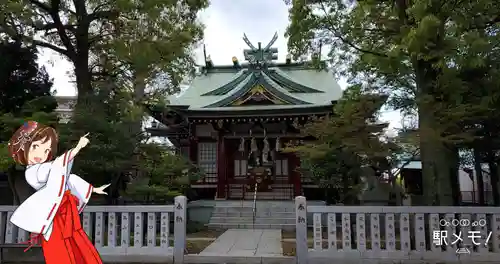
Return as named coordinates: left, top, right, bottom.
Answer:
left=8, top=121, right=109, bottom=264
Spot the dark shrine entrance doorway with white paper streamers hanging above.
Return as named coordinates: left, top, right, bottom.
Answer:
left=225, top=131, right=298, bottom=200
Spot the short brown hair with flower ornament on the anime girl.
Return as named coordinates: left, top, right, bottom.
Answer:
left=8, top=121, right=59, bottom=165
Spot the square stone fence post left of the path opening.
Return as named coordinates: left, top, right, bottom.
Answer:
left=174, top=196, right=187, bottom=264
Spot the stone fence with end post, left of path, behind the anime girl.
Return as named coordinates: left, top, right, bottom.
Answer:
left=0, top=196, right=187, bottom=264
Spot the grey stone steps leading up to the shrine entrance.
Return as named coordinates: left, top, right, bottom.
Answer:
left=207, top=200, right=295, bottom=231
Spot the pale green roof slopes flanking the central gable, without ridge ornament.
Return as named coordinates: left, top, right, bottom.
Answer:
left=169, top=65, right=342, bottom=110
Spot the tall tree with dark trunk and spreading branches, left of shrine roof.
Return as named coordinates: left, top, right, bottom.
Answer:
left=0, top=0, right=208, bottom=108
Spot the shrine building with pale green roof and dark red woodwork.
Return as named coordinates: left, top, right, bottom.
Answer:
left=148, top=34, right=342, bottom=200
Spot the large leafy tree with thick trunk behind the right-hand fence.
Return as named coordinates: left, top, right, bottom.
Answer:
left=287, top=0, right=500, bottom=205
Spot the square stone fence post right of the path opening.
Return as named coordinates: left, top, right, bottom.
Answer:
left=295, top=196, right=308, bottom=264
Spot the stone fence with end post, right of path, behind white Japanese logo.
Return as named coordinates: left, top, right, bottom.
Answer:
left=295, top=196, right=500, bottom=264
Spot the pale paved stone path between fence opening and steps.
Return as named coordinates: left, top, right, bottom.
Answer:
left=199, top=229, right=283, bottom=257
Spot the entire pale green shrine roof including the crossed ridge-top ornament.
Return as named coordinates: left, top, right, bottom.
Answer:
left=169, top=34, right=342, bottom=111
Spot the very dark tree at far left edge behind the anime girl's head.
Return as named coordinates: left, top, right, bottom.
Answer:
left=0, top=41, right=57, bottom=204
